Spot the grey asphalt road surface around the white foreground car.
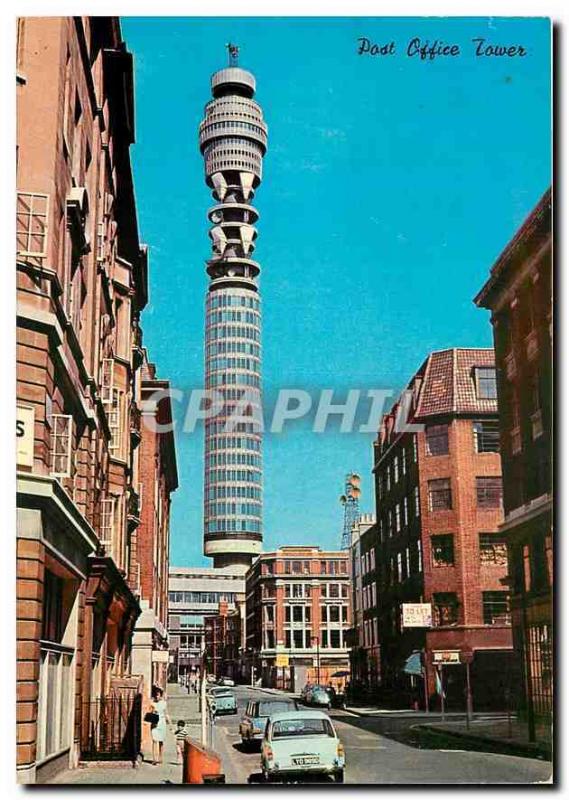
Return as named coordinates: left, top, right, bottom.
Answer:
left=210, top=686, right=551, bottom=785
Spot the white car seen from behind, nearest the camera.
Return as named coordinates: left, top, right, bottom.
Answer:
left=261, top=709, right=346, bottom=783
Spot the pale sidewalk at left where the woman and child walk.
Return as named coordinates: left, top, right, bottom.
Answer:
left=50, top=683, right=201, bottom=785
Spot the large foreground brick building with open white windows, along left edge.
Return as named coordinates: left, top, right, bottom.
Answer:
left=16, top=17, right=173, bottom=783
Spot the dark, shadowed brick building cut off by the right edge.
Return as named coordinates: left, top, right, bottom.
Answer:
left=475, top=190, right=553, bottom=738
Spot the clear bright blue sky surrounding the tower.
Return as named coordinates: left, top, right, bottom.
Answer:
left=122, top=17, right=551, bottom=565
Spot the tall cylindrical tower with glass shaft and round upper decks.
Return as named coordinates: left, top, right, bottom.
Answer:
left=199, top=59, right=267, bottom=567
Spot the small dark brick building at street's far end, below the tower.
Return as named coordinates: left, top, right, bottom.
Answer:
left=205, top=600, right=242, bottom=681
